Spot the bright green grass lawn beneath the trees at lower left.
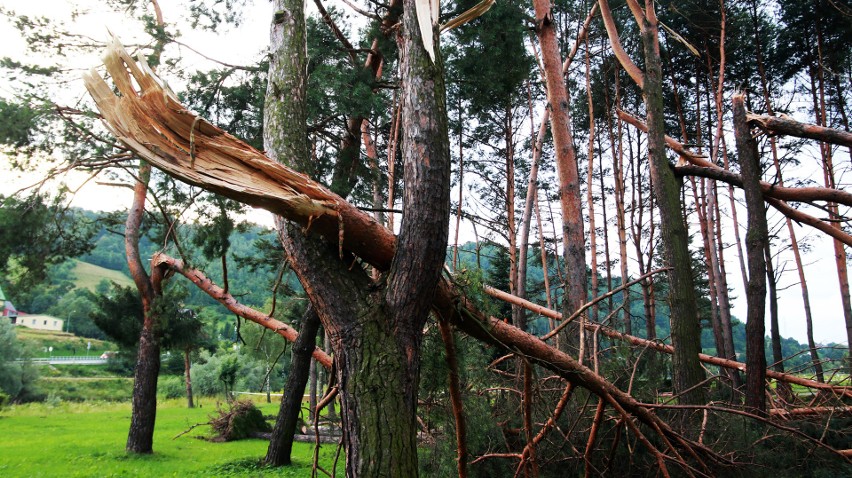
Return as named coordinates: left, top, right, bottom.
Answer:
left=0, top=399, right=344, bottom=477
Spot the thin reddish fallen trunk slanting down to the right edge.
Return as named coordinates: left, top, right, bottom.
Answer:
left=484, top=286, right=852, bottom=398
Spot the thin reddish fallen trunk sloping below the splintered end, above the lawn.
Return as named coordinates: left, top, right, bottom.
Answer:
left=151, top=252, right=331, bottom=369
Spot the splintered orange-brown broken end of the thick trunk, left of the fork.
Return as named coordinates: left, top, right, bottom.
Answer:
left=83, top=38, right=392, bottom=268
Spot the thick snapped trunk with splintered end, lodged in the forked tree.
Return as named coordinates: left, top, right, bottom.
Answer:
left=84, top=40, right=730, bottom=467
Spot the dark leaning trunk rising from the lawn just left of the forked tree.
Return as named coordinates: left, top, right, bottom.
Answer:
left=264, top=308, right=320, bottom=466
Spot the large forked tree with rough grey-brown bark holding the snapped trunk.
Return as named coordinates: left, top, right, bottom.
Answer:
left=264, top=0, right=450, bottom=476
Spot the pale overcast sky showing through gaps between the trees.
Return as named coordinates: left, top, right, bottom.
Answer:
left=0, top=0, right=846, bottom=343
